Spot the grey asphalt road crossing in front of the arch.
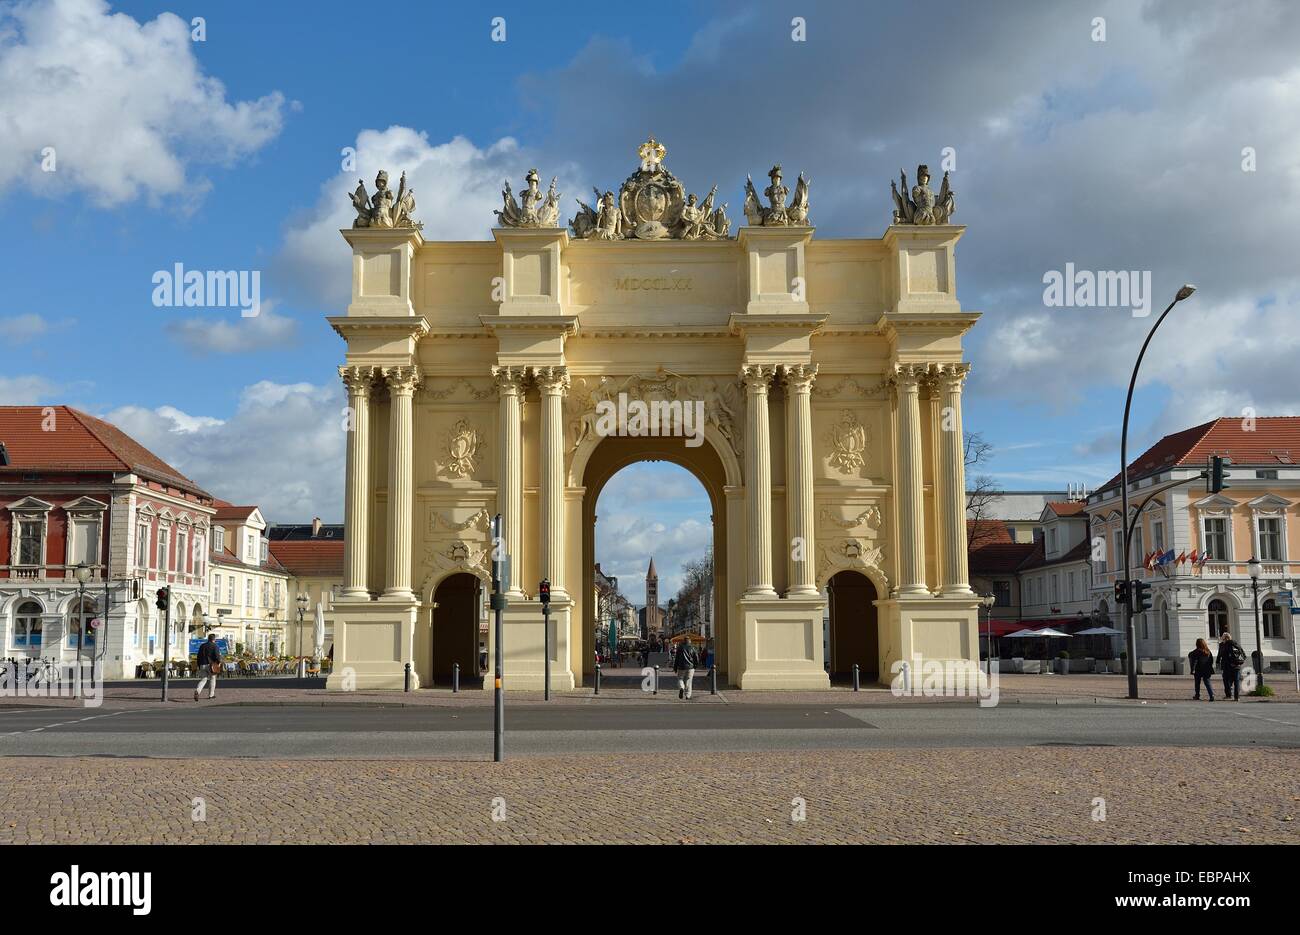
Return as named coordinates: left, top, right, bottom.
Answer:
left=0, top=702, right=1300, bottom=759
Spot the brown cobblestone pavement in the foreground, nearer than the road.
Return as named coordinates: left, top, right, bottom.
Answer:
left=0, top=748, right=1300, bottom=844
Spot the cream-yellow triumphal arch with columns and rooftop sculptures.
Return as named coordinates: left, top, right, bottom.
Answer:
left=329, top=139, right=979, bottom=689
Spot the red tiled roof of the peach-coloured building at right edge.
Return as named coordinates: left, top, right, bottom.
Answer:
left=1099, top=416, right=1300, bottom=490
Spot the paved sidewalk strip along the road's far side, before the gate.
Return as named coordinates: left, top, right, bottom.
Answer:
left=0, top=674, right=1300, bottom=709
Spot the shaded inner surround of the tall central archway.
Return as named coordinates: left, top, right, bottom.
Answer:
left=573, top=437, right=733, bottom=684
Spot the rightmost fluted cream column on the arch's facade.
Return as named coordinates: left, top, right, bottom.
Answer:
left=935, top=364, right=974, bottom=597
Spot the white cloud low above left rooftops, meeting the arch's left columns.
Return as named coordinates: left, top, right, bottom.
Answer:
left=103, top=381, right=347, bottom=523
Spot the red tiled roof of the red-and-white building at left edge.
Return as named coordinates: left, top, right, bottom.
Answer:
left=0, top=406, right=208, bottom=497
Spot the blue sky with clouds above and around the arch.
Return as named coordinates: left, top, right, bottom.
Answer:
left=0, top=0, right=1300, bottom=596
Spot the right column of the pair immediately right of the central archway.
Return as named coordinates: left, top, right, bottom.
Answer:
left=783, top=364, right=818, bottom=597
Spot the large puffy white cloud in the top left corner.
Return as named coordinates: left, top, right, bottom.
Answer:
left=0, top=0, right=285, bottom=208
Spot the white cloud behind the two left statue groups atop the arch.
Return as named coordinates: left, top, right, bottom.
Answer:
left=281, top=126, right=575, bottom=307
